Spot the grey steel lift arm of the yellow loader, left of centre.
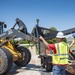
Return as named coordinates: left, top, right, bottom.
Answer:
left=0, top=18, right=37, bottom=41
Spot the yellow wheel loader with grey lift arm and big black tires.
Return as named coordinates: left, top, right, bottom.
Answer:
left=0, top=18, right=31, bottom=75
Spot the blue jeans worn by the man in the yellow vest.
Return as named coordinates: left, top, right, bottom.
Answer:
left=52, top=65, right=66, bottom=75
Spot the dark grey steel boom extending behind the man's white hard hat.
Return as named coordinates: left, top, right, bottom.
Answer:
left=31, top=25, right=75, bottom=40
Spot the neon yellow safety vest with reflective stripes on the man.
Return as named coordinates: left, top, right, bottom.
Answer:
left=53, top=42, right=68, bottom=65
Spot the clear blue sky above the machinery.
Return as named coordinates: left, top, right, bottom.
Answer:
left=0, top=0, right=75, bottom=32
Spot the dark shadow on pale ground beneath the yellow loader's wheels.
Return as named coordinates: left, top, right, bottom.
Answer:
left=4, top=64, right=41, bottom=75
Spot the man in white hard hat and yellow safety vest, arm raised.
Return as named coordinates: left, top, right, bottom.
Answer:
left=40, top=32, right=69, bottom=75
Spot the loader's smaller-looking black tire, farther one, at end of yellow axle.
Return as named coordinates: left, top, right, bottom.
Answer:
left=14, top=46, right=31, bottom=67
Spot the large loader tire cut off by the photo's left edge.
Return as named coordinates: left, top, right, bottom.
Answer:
left=0, top=48, right=13, bottom=75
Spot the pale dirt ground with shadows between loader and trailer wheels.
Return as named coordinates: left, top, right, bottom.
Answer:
left=5, top=47, right=75, bottom=75
